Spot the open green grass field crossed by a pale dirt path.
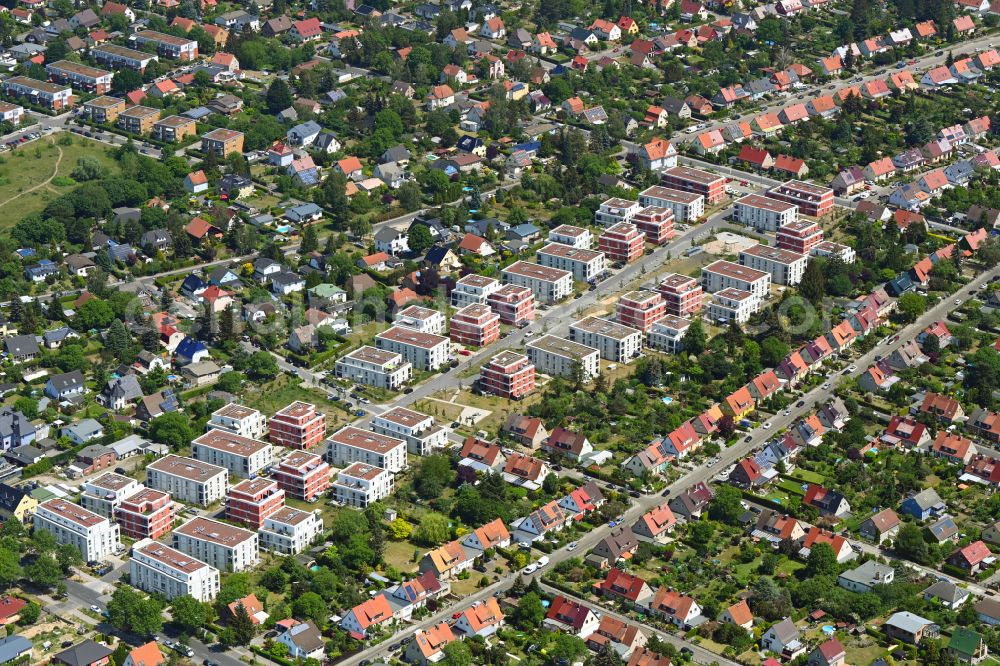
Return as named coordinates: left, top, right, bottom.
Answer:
left=0, top=133, right=118, bottom=228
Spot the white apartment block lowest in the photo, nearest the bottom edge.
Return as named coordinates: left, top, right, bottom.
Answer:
left=129, top=539, right=221, bottom=602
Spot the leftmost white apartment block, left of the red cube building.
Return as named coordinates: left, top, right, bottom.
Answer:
left=34, top=499, right=122, bottom=562
